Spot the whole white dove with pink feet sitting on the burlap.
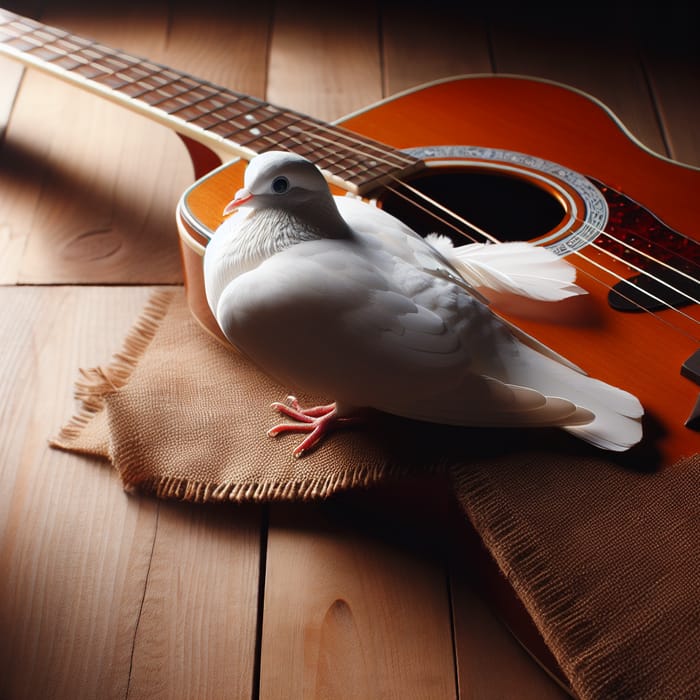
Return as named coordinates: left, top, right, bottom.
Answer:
left=204, top=151, right=643, bottom=456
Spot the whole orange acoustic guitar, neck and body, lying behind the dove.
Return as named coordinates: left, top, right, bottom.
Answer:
left=0, top=5, right=700, bottom=468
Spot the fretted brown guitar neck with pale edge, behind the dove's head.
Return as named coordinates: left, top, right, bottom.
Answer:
left=0, top=8, right=422, bottom=194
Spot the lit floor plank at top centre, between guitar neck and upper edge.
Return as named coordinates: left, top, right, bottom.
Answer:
left=267, top=0, right=382, bottom=121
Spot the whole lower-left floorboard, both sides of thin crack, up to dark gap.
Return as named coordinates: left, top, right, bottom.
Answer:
left=0, top=287, right=260, bottom=698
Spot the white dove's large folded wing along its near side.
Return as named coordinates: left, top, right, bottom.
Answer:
left=216, top=232, right=592, bottom=425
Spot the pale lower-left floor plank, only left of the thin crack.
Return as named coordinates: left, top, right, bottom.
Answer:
left=0, top=288, right=156, bottom=698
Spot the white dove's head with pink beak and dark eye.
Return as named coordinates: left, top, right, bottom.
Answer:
left=224, top=151, right=344, bottom=237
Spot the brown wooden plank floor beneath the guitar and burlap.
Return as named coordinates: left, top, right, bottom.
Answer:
left=0, top=0, right=700, bottom=700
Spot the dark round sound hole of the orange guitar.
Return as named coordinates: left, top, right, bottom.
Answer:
left=380, top=169, right=566, bottom=245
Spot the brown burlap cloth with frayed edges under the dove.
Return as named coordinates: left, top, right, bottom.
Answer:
left=52, top=291, right=700, bottom=700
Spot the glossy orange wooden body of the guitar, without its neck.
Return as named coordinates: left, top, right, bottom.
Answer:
left=178, top=76, right=700, bottom=468
